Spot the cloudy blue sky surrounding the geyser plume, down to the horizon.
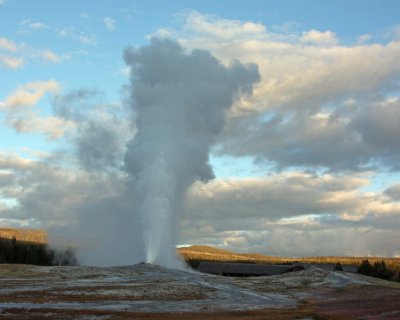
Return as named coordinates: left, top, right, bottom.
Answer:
left=0, top=0, right=400, bottom=259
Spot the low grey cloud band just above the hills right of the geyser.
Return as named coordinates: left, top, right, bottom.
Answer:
left=187, top=223, right=399, bottom=257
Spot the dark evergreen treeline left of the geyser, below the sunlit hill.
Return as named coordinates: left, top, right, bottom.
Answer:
left=0, top=237, right=77, bottom=266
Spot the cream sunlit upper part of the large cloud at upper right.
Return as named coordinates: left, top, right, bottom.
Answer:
left=175, top=13, right=400, bottom=114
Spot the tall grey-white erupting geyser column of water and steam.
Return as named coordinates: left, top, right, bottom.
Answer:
left=124, top=39, right=259, bottom=267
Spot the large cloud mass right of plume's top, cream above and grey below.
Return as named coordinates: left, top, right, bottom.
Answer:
left=160, top=13, right=400, bottom=172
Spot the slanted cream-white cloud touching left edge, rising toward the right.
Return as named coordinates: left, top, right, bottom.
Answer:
left=0, top=80, right=61, bottom=109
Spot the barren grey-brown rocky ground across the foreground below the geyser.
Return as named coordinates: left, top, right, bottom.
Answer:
left=0, top=264, right=400, bottom=320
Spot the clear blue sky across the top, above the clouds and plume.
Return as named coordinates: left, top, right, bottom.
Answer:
left=0, top=1, right=400, bottom=155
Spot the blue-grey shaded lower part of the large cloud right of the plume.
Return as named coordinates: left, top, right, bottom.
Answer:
left=220, top=99, right=400, bottom=171
